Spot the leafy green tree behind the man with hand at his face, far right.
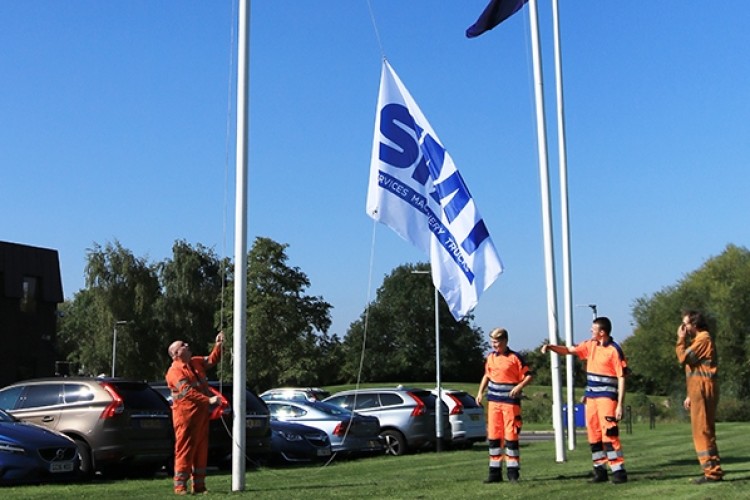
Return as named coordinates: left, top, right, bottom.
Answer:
left=625, top=245, right=750, bottom=399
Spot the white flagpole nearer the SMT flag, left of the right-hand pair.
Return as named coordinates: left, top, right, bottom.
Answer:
left=529, top=0, right=565, bottom=462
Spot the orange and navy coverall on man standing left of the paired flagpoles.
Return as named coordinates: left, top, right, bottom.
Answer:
left=485, top=347, right=529, bottom=469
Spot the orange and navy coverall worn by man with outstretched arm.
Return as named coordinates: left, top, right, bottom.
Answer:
left=573, top=339, right=627, bottom=472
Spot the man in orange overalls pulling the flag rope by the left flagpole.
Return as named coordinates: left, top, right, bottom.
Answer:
left=166, top=332, right=224, bottom=495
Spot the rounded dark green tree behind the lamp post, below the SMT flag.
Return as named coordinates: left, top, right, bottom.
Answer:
left=342, top=263, right=486, bottom=382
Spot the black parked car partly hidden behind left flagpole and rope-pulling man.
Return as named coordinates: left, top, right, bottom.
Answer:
left=151, top=381, right=271, bottom=467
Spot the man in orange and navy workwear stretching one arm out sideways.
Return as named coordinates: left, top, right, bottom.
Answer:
left=542, top=316, right=628, bottom=484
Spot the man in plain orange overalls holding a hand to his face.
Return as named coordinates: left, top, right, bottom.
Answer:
left=675, top=311, right=724, bottom=484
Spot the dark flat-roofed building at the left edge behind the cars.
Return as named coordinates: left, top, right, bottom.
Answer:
left=0, top=241, right=63, bottom=387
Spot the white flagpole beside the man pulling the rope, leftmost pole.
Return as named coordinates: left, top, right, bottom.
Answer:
left=232, top=0, right=250, bottom=491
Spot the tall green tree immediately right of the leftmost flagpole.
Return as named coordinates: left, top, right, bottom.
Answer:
left=226, top=237, right=338, bottom=390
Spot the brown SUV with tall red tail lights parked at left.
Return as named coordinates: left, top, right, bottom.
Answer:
left=0, top=377, right=174, bottom=476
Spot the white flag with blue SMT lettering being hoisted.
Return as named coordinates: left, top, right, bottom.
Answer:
left=367, top=61, right=503, bottom=320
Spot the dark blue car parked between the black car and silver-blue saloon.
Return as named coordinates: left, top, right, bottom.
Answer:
left=271, top=419, right=332, bottom=462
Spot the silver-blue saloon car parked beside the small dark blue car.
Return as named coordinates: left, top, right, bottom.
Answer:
left=266, top=401, right=383, bottom=454
